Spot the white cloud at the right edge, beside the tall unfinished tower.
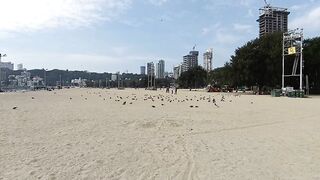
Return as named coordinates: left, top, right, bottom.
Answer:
left=290, top=6, right=320, bottom=31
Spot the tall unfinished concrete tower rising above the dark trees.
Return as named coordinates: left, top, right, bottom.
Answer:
left=257, top=5, right=290, bottom=37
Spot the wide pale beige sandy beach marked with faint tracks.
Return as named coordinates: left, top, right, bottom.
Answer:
left=0, top=89, right=320, bottom=180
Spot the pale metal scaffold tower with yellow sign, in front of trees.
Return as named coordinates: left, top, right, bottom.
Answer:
left=282, top=28, right=303, bottom=91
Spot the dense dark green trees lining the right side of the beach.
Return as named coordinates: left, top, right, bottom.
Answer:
left=178, top=33, right=320, bottom=93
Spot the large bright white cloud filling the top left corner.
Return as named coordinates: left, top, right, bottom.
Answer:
left=0, top=0, right=132, bottom=32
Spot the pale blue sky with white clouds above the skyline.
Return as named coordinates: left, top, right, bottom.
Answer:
left=0, top=0, right=320, bottom=73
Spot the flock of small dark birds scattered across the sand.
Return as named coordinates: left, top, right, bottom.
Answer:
left=12, top=91, right=248, bottom=110
